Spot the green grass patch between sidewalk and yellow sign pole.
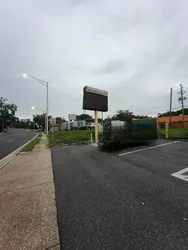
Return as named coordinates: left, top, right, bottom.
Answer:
left=48, top=130, right=94, bottom=147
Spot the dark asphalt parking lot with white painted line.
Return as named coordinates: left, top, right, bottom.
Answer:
left=52, top=142, right=188, bottom=250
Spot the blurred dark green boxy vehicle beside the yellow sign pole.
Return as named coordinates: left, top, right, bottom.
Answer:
left=99, top=118, right=158, bottom=146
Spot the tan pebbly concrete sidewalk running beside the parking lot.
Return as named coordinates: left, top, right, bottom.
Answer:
left=0, top=136, right=60, bottom=250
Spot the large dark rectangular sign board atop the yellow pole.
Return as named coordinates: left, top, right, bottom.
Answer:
left=83, top=86, right=108, bottom=112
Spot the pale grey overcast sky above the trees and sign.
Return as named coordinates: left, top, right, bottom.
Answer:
left=0, top=0, right=188, bottom=118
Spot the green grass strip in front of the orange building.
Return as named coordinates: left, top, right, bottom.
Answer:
left=158, top=128, right=188, bottom=139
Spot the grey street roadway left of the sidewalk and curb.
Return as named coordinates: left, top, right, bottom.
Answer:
left=0, top=129, right=36, bottom=160
